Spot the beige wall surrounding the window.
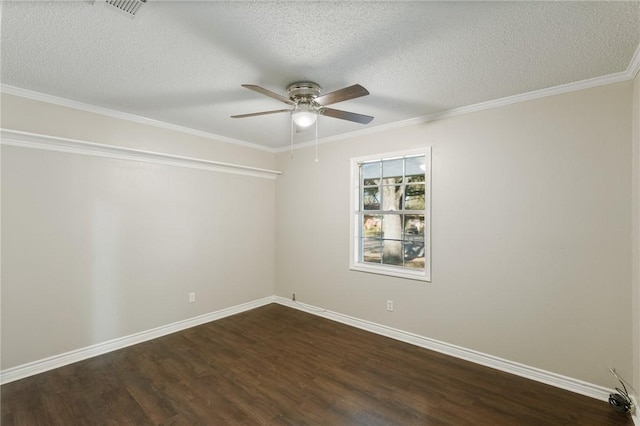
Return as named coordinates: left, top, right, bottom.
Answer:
left=276, top=82, right=632, bottom=386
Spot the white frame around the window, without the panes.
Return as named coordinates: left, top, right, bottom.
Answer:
left=349, top=147, right=431, bottom=282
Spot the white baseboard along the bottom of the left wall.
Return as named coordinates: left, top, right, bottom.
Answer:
left=0, top=296, right=275, bottom=384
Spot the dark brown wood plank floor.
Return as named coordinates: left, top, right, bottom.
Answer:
left=2, top=304, right=633, bottom=426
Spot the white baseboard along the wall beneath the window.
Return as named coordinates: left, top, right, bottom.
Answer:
left=275, top=296, right=616, bottom=402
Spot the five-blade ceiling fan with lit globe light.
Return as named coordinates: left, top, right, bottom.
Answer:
left=231, top=81, right=373, bottom=127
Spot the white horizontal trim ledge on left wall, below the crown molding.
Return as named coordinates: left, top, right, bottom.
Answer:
left=0, top=129, right=282, bottom=179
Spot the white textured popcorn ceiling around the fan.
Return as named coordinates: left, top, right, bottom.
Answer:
left=1, top=0, right=640, bottom=148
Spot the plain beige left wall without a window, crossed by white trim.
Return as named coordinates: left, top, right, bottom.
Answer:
left=1, top=96, right=275, bottom=370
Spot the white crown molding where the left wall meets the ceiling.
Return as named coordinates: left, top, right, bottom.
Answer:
left=0, top=84, right=274, bottom=153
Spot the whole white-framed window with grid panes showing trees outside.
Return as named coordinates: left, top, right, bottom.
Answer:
left=350, top=149, right=431, bottom=281
